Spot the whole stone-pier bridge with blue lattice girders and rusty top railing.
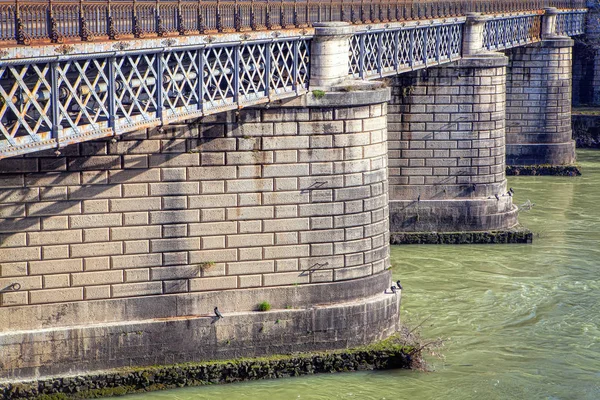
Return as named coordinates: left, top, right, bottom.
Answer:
left=0, top=0, right=586, bottom=380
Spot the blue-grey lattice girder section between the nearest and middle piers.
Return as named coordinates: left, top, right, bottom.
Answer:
left=349, top=18, right=464, bottom=79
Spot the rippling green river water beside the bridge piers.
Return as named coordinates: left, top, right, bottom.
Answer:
left=122, top=151, right=600, bottom=400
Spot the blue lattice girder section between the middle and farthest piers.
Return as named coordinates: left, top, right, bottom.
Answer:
left=483, top=12, right=542, bottom=50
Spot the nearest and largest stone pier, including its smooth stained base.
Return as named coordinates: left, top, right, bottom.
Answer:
left=0, top=51, right=400, bottom=380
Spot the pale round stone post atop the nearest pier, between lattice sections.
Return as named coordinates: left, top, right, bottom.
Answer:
left=310, top=22, right=354, bottom=88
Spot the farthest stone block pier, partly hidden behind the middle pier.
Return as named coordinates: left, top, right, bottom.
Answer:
left=506, top=38, right=575, bottom=165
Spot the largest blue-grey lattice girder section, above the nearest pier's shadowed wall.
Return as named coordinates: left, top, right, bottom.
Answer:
left=0, top=38, right=310, bottom=158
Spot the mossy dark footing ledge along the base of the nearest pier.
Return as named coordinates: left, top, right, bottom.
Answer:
left=0, top=336, right=414, bottom=400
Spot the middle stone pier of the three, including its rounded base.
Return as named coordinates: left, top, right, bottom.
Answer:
left=388, top=53, right=517, bottom=241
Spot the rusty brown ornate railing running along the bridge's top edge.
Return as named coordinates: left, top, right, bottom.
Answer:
left=0, top=0, right=585, bottom=44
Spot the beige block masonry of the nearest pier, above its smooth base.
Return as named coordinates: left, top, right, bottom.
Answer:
left=0, top=99, right=389, bottom=312
